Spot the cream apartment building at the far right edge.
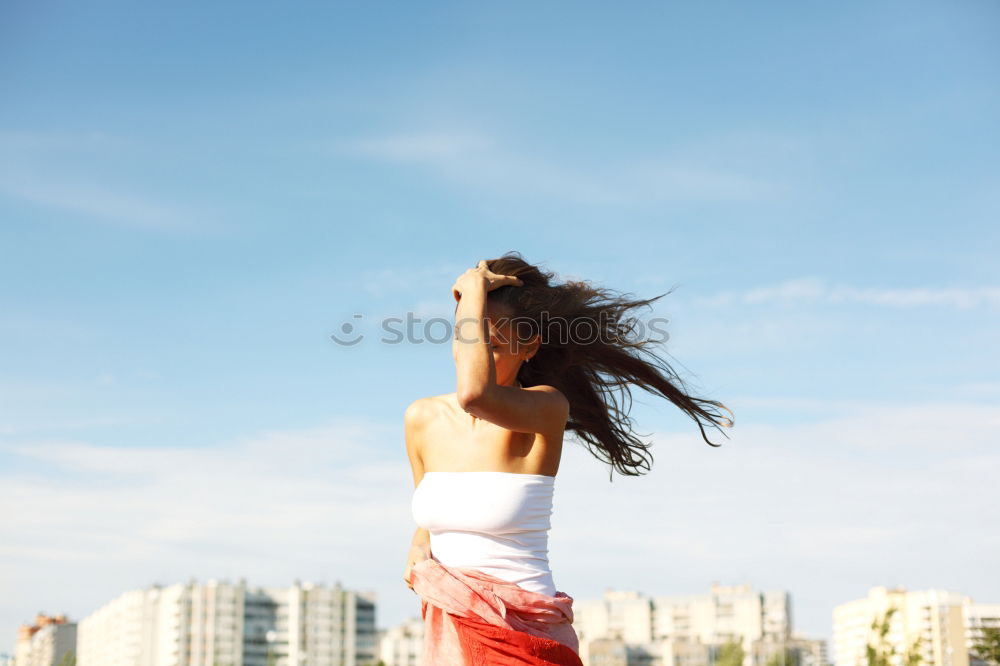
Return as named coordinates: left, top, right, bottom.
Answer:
left=833, top=587, right=1000, bottom=666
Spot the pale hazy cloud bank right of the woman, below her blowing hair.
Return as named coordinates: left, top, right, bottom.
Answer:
left=550, top=397, right=1000, bottom=635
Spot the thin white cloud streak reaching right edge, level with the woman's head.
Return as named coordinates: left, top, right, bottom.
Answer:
left=698, top=277, right=1000, bottom=309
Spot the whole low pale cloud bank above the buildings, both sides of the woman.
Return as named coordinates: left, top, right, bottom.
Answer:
left=0, top=397, right=1000, bottom=635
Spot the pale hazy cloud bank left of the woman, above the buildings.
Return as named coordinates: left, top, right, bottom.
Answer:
left=0, top=419, right=413, bottom=622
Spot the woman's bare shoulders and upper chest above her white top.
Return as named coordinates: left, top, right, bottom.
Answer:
left=416, top=393, right=565, bottom=476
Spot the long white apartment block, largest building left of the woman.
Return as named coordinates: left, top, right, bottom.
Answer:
left=77, top=579, right=376, bottom=666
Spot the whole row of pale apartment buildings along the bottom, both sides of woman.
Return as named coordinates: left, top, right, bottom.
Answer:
left=9, top=578, right=1000, bottom=666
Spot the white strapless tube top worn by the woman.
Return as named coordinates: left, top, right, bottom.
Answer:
left=411, top=471, right=556, bottom=596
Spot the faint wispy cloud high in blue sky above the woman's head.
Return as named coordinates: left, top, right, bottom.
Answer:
left=327, top=131, right=787, bottom=204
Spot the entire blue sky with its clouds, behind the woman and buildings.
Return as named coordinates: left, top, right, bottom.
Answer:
left=0, top=1, right=1000, bottom=646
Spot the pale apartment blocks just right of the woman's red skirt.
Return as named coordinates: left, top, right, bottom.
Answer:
left=573, top=584, right=827, bottom=666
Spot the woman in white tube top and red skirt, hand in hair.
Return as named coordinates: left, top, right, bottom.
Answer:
left=403, top=252, right=733, bottom=666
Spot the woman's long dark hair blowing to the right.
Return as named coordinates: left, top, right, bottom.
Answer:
left=486, top=251, right=734, bottom=476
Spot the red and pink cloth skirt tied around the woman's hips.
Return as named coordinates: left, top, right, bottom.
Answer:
left=410, top=557, right=583, bottom=666
